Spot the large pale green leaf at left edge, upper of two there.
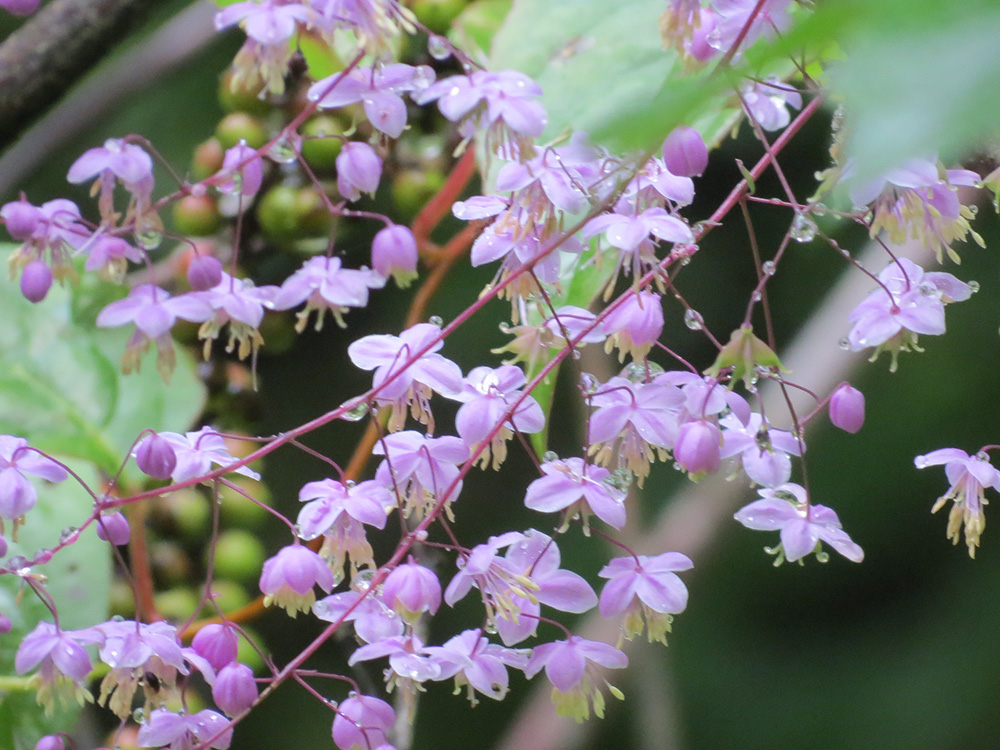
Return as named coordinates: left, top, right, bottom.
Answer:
left=0, top=250, right=205, bottom=474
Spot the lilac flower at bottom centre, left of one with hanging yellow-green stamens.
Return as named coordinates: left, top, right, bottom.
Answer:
left=425, top=628, right=527, bottom=705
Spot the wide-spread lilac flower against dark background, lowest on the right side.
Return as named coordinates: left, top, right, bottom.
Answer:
left=734, top=483, right=865, bottom=565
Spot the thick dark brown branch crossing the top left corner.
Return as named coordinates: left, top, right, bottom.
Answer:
left=0, top=0, right=174, bottom=146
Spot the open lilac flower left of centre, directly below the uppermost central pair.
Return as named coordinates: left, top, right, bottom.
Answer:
left=372, top=430, right=469, bottom=518
